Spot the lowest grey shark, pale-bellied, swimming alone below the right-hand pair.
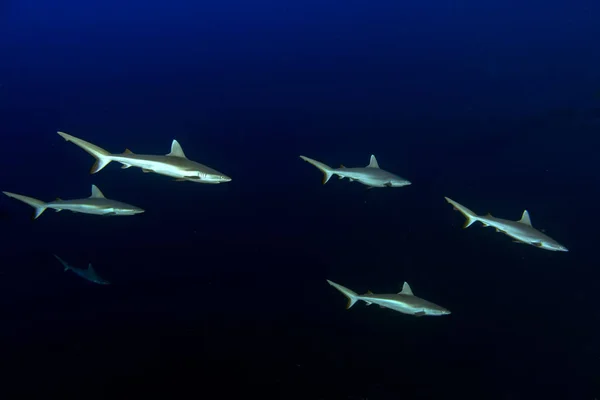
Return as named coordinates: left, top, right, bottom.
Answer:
left=327, top=279, right=450, bottom=317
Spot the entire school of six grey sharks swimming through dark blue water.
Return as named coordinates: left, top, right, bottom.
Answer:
left=3, top=132, right=568, bottom=317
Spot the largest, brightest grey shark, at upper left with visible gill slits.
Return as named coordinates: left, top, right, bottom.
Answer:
left=58, top=132, right=231, bottom=184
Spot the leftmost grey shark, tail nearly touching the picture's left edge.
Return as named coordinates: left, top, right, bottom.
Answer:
left=2, top=185, right=144, bottom=219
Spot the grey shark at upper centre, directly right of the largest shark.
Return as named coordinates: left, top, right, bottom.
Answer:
left=300, top=155, right=411, bottom=189
